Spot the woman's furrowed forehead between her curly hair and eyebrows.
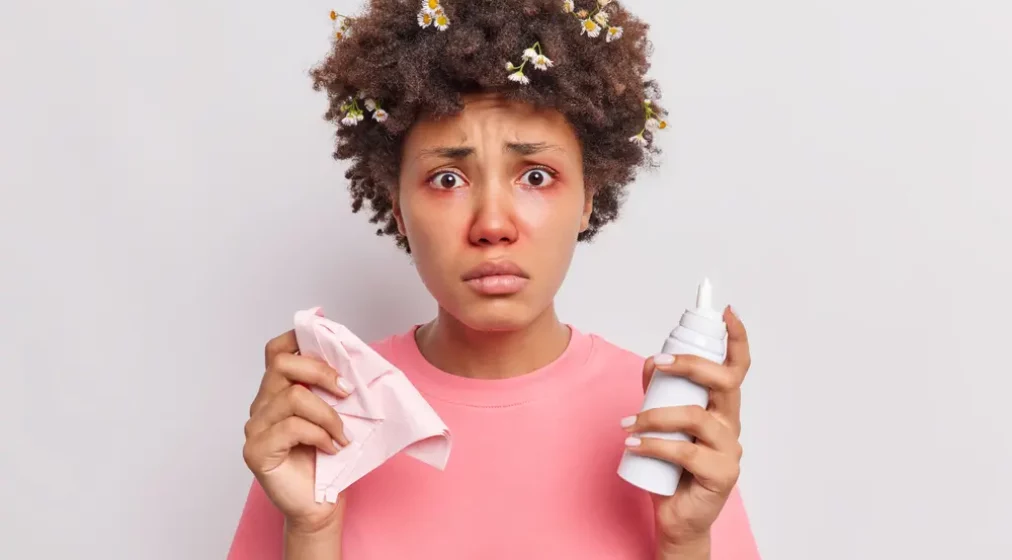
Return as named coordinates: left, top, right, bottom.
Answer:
left=404, top=93, right=579, bottom=154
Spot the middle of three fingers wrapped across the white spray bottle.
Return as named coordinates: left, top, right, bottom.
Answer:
left=622, top=405, right=741, bottom=455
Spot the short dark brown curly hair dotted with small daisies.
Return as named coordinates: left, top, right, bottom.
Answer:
left=311, top=0, right=664, bottom=252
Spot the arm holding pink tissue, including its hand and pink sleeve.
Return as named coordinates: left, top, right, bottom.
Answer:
left=228, top=331, right=348, bottom=560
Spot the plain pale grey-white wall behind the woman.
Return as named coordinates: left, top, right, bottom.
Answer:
left=0, top=0, right=1012, bottom=560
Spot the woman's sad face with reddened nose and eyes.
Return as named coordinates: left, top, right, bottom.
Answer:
left=394, top=94, right=593, bottom=331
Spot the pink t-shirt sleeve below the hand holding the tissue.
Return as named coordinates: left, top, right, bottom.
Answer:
left=228, top=479, right=284, bottom=560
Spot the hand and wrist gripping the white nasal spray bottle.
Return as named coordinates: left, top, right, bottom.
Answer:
left=623, top=307, right=751, bottom=558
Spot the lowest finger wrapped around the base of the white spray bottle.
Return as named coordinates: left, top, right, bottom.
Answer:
left=625, top=436, right=740, bottom=494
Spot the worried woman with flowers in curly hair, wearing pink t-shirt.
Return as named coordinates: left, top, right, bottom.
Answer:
left=230, top=0, right=758, bottom=560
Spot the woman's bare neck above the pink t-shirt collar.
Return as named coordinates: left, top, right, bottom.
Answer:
left=415, top=306, right=571, bottom=379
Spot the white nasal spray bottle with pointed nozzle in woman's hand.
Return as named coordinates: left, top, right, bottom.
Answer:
left=618, top=278, right=728, bottom=496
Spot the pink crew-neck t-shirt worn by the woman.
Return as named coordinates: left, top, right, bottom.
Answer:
left=229, top=328, right=759, bottom=560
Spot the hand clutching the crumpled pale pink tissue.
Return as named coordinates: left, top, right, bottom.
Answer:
left=243, top=331, right=348, bottom=534
